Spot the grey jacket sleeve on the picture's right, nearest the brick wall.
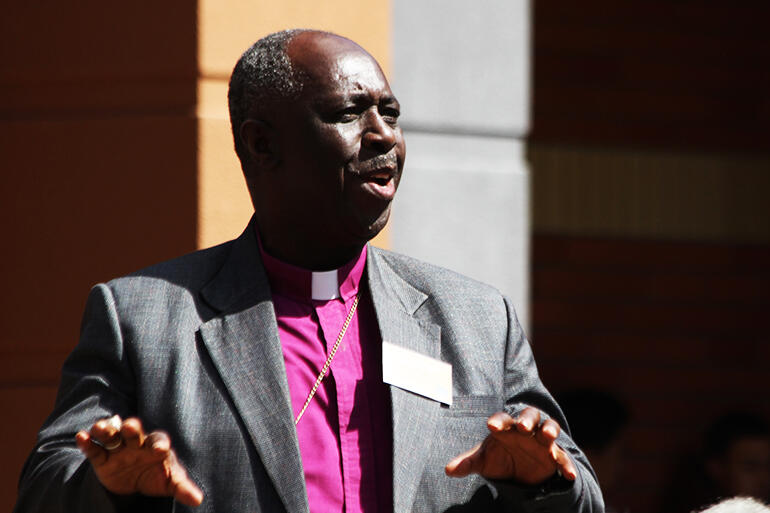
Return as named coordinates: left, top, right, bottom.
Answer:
left=493, top=298, right=604, bottom=513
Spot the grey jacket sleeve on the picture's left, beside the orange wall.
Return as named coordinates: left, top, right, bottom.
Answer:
left=14, top=284, right=171, bottom=513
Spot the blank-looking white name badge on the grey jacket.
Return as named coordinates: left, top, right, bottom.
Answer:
left=382, top=341, right=452, bottom=405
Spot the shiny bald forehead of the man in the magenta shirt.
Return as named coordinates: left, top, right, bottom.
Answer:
left=288, top=32, right=391, bottom=100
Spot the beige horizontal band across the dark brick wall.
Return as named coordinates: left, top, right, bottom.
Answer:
left=529, top=144, right=770, bottom=243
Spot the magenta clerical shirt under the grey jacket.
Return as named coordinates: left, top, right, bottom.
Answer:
left=260, top=237, right=393, bottom=513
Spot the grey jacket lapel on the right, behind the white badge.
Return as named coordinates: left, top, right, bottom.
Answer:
left=367, top=247, right=441, bottom=511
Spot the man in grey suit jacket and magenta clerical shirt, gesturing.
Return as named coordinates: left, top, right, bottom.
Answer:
left=12, top=31, right=603, bottom=512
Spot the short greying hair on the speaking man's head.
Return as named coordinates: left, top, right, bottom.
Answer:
left=227, top=29, right=307, bottom=164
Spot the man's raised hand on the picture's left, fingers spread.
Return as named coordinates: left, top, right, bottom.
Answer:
left=75, top=415, right=203, bottom=506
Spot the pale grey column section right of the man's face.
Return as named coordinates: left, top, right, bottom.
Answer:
left=391, top=0, right=530, bottom=325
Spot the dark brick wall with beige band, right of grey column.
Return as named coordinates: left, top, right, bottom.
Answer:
left=529, top=1, right=770, bottom=513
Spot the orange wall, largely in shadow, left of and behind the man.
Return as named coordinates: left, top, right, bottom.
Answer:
left=0, top=0, right=390, bottom=511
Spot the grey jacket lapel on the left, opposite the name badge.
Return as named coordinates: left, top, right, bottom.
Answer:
left=200, top=223, right=308, bottom=512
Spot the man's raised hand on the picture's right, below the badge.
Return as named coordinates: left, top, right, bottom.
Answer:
left=444, top=407, right=577, bottom=485
